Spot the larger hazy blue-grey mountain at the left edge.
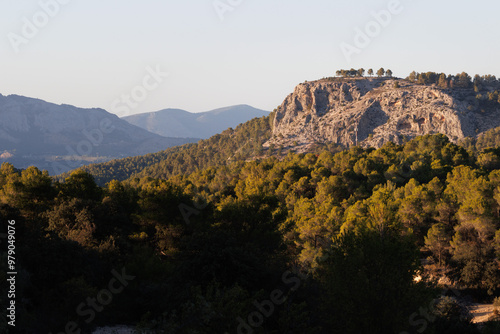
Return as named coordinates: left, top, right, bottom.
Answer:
left=0, top=94, right=198, bottom=174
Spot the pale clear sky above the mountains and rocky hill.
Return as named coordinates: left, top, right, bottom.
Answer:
left=0, top=0, right=500, bottom=116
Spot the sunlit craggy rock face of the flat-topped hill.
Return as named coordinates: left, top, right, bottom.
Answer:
left=264, top=78, right=500, bottom=152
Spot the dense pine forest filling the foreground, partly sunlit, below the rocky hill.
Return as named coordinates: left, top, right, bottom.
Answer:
left=0, top=134, right=500, bottom=334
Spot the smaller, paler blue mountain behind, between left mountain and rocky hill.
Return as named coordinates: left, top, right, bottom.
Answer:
left=123, top=104, right=269, bottom=139
